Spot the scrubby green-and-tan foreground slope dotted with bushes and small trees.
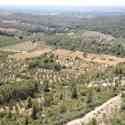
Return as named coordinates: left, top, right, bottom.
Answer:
left=0, top=50, right=124, bottom=125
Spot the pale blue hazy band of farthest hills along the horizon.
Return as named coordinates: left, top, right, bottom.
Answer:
left=0, top=5, right=125, bottom=15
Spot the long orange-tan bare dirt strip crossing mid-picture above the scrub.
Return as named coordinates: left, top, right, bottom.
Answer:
left=10, top=47, right=125, bottom=65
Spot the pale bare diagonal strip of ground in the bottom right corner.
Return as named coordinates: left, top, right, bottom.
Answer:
left=66, top=95, right=121, bottom=125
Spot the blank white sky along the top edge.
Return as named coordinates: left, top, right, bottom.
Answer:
left=0, top=0, right=125, bottom=6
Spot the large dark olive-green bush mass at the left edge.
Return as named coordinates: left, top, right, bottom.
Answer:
left=0, top=81, right=38, bottom=104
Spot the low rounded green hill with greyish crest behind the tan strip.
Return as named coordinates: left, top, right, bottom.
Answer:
left=43, top=31, right=125, bottom=56
